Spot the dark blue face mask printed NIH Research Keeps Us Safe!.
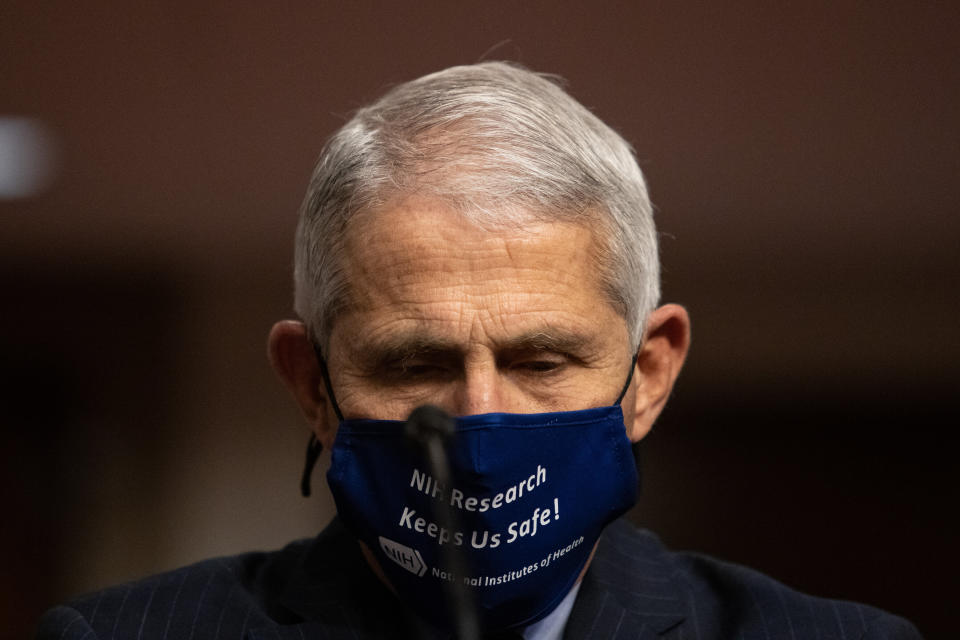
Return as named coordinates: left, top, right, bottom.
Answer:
left=312, top=360, right=637, bottom=630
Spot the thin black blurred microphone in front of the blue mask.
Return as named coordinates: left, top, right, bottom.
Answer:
left=403, top=405, right=480, bottom=640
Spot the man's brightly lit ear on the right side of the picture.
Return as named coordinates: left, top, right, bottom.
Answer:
left=628, top=304, right=690, bottom=442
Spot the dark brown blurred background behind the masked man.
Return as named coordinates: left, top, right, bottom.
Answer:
left=0, top=0, right=960, bottom=638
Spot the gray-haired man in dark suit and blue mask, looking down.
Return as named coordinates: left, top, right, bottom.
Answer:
left=41, top=63, right=918, bottom=639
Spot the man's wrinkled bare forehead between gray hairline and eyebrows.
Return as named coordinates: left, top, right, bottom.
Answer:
left=326, top=199, right=622, bottom=351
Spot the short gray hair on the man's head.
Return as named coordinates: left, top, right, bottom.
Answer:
left=294, top=62, right=660, bottom=349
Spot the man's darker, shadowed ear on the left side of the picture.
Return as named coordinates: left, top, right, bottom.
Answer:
left=267, top=320, right=337, bottom=450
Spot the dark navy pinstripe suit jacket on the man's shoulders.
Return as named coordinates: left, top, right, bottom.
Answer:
left=38, top=520, right=920, bottom=640
